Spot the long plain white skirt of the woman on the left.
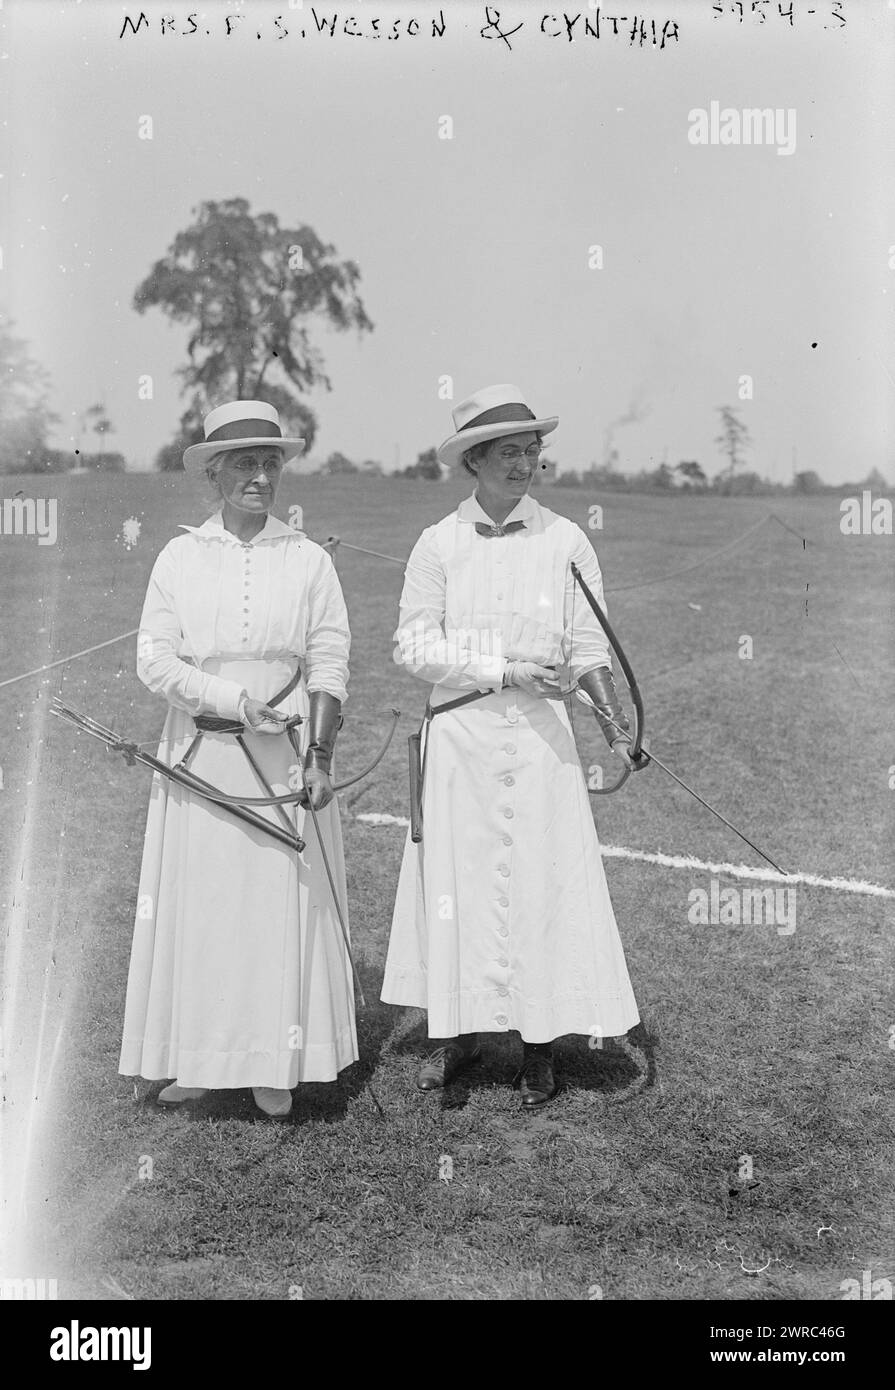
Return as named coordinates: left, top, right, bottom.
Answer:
left=120, top=660, right=359, bottom=1088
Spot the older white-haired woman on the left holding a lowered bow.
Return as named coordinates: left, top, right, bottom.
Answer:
left=120, top=400, right=357, bottom=1115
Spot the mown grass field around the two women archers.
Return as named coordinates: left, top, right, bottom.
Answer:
left=0, top=475, right=895, bottom=1300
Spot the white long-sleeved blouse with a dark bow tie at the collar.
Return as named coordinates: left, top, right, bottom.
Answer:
left=395, top=495, right=611, bottom=700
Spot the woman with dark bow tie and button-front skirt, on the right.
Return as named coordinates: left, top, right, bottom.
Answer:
left=382, top=386, right=643, bottom=1111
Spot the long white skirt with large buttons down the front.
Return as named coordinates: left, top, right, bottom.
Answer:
left=382, top=689, right=639, bottom=1043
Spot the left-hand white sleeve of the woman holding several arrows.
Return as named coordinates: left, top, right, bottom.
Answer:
left=136, top=545, right=246, bottom=719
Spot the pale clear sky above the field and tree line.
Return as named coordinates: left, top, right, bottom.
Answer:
left=0, top=0, right=895, bottom=482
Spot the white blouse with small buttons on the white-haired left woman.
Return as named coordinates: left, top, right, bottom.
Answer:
left=136, top=512, right=350, bottom=719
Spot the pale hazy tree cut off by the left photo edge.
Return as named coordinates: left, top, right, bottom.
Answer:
left=0, top=317, right=58, bottom=473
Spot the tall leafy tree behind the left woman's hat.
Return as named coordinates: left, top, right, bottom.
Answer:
left=133, top=197, right=372, bottom=469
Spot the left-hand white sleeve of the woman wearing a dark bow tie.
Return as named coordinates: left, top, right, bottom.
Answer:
left=395, top=527, right=507, bottom=691
